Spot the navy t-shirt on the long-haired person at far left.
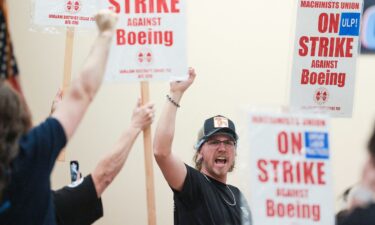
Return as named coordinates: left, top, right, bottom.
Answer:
left=0, top=118, right=66, bottom=225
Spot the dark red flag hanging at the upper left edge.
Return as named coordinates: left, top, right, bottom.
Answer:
left=0, top=0, right=22, bottom=93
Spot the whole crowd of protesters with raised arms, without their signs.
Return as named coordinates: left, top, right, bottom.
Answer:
left=0, top=5, right=375, bottom=225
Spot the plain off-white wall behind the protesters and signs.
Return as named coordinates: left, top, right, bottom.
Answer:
left=8, top=0, right=375, bottom=225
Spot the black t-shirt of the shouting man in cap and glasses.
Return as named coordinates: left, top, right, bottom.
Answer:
left=174, top=165, right=251, bottom=225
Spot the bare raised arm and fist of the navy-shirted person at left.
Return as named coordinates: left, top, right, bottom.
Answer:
left=52, top=10, right=117, bottom=139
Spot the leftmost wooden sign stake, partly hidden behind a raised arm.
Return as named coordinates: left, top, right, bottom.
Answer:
left=57, top=27, right=74, bottom=162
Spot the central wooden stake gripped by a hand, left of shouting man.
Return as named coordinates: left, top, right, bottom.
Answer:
left=141, top=81, right=156, bottom=225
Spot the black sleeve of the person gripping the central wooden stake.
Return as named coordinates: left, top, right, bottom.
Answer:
left=53, top=175, right=103, bottom=225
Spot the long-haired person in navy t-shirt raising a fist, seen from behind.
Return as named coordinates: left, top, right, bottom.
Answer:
left=0, top=10, right=117, bottom=225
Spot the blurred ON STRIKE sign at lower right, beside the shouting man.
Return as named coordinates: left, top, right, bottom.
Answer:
left=248, top=110, right=334, bottom=225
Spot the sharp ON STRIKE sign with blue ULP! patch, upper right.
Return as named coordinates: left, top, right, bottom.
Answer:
left=290, top=0, right=362, bottom=117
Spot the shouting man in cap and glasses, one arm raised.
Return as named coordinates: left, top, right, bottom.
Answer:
left=154, top=69, right=251, bottom=225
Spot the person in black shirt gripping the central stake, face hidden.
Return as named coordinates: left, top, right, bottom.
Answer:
left=51, top=91, right=155, bottom=225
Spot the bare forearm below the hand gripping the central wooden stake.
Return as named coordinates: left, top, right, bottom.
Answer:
left=92, top=127, right=141, bottom=197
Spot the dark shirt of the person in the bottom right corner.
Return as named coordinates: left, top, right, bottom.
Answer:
left=337, top=204, right=375, bottom=225
